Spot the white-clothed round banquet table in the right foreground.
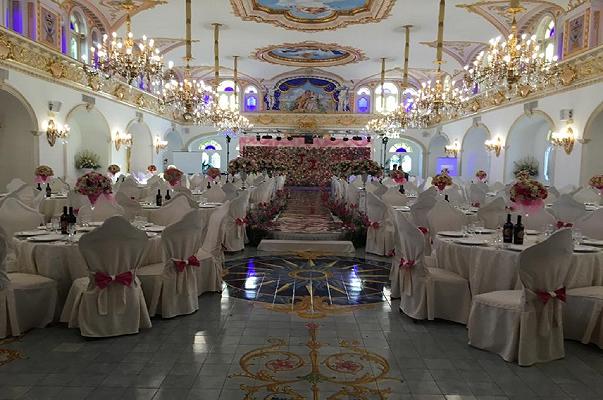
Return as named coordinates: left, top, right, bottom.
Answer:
left=433, top=235, right=603, bottom=295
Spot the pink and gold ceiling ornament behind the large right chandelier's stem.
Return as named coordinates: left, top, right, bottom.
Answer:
left=457, top=0, right=565, bottom=36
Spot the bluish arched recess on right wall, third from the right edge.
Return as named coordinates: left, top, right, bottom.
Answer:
left=461, top=125, right=490, bottom=181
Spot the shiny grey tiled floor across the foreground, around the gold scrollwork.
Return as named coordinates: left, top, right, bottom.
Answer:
left=0, top=252, right=603, bottom=400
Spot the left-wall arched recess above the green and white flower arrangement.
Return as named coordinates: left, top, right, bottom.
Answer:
left=65, top=105, right=111, bottom=182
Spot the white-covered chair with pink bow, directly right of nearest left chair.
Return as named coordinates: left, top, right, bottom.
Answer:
left=137, top=210, right=204, bottom=318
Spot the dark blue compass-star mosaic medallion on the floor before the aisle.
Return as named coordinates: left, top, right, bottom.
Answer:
left=224, top=254, right=390, bottom=318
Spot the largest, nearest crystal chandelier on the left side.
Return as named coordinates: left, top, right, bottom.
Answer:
left=84, top=0, right=163, bottom=88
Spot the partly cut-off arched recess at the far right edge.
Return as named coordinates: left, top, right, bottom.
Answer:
left=580, top=104, right=603, bottom=185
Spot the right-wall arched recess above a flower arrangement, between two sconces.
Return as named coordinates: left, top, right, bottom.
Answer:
left=505, top=111, right=555, bottom=185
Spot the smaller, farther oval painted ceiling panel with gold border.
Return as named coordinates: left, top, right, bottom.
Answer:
left=252, top=42, right=366, bottom=67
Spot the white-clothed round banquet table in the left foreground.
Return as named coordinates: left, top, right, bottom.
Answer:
left=14, top=228, right=163, bottom=312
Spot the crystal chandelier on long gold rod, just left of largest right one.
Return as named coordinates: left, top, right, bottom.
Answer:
left=415, top=0, right=466, bottom=125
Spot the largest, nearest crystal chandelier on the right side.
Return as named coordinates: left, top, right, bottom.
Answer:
left=465, top=0, right=558, bottom=97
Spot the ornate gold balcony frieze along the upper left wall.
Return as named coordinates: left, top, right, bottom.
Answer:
left=0, top=27, right=172, bottom=120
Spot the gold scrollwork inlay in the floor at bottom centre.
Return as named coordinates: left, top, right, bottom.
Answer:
left=230, top=323, right=399, bottom=400
